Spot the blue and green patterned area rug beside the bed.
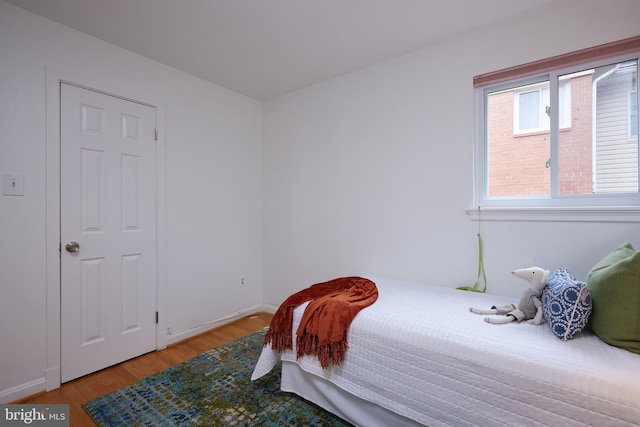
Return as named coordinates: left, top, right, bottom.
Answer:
left=83, top=331, right=350, bottom=427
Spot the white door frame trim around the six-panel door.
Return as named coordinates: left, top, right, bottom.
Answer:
left=45, top=67, right=168, bottom=391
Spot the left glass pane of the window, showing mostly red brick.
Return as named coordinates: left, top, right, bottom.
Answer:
left=486, top=86, right=550, bottom=198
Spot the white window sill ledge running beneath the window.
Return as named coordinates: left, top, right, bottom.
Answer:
left=467, top=206, right=640, bottom=223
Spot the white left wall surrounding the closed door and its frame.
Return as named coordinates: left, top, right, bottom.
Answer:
left=0, top=0, right=262, bottom=402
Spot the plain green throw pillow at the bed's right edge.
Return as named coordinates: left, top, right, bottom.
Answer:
left=587, top=243, right=640, bottom=354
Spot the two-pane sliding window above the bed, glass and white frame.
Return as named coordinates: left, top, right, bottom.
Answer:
left=474, top=37, right=640, bottom=211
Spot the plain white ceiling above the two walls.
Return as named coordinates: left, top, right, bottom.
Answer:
left=8, top=0, right=562, bottom=101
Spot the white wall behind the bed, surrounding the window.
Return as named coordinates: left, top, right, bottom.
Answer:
left=263, top=0, right=640, bottom=305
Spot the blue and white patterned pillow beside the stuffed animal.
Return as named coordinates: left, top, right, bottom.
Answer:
left=542, top=268, right=592, bottom=341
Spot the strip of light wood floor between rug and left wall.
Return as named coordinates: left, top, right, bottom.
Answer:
left=14, top=313, right=272, bottom=427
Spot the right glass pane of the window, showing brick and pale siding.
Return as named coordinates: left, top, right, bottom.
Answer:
left=558, top=61, right=638, bottom=195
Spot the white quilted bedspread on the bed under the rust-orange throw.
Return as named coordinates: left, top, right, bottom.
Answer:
left=252, top=277, right=640, bottom=427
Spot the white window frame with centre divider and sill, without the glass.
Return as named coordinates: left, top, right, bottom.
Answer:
left=467, top=52, right=640, bottom=222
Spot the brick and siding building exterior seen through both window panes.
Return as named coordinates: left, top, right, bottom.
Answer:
left=486, top=61, right=638, bottom=198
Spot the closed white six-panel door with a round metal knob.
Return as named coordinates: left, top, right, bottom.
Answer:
left=60, top=83, right=157, bottom=382
